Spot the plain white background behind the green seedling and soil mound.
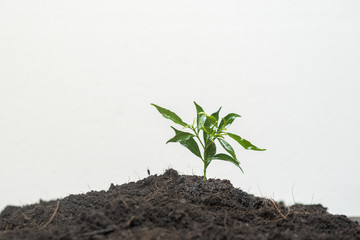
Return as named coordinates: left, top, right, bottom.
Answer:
left=0, top=0, right=360, bottom=215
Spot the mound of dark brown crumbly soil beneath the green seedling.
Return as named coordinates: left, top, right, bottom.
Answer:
left=0, top=169, right=360, bottom=240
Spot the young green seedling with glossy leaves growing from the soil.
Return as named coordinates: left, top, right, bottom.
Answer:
left=151, top=102, right=266, bottom=181
